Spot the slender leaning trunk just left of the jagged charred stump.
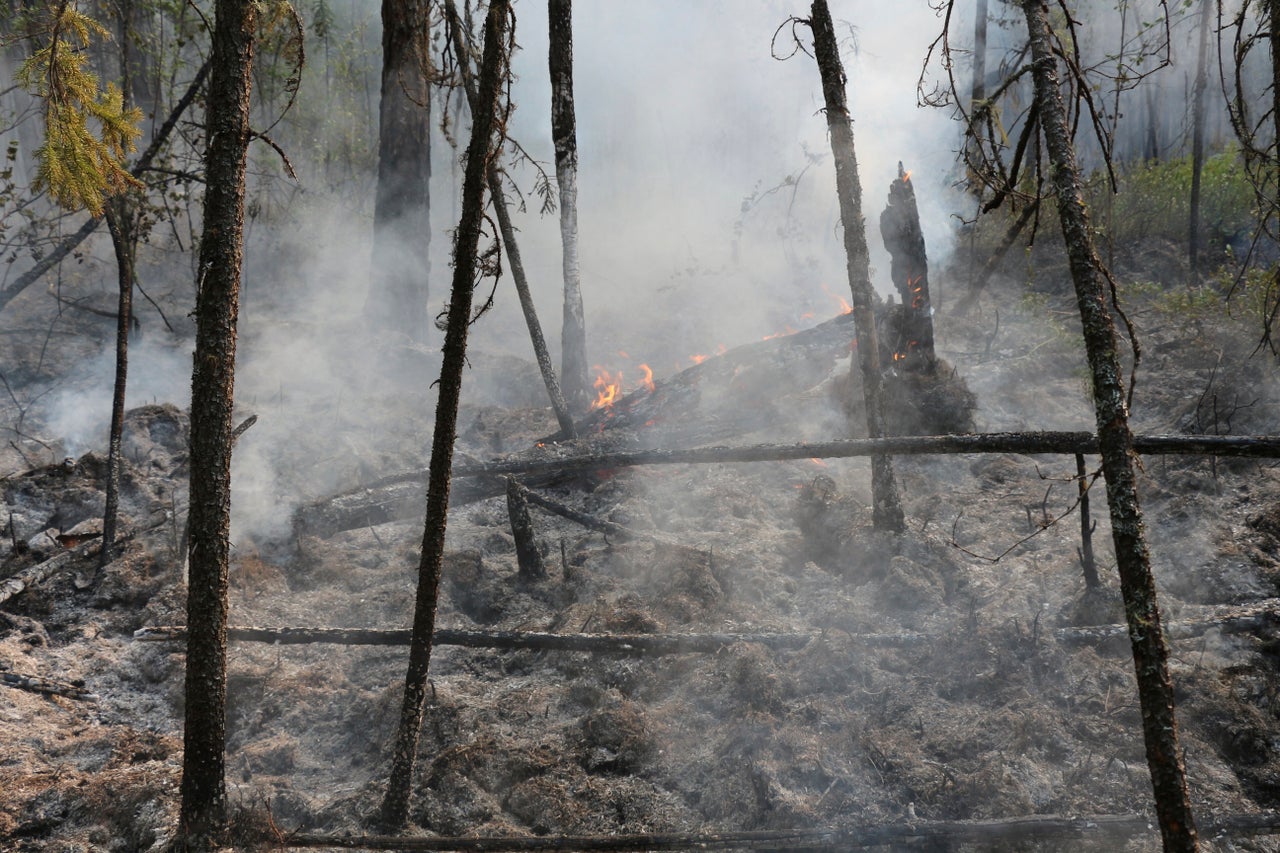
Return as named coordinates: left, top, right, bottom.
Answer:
left=809, top=0, right=904, bottom=533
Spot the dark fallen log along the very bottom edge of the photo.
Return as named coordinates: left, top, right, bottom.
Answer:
left=259, top=812, right=1280, bottom=853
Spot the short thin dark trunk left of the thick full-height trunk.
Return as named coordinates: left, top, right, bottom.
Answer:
left=99, top=195, right=138, bottom=569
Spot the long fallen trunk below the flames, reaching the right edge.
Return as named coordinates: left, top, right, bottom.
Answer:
left=294, top=432, right=1280, bottom=538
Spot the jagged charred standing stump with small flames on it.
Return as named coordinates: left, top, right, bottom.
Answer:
left=881, top=163, right=938, bottom=374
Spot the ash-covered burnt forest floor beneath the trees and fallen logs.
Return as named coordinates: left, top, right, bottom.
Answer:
left=0, top=235, right=1280, bottom=852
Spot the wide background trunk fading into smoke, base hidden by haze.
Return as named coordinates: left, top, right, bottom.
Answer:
left=365, top=0, right=431, bottom=342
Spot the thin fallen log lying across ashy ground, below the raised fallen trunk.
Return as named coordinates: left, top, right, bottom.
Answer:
left=133, top=598, right=1280, bottom=656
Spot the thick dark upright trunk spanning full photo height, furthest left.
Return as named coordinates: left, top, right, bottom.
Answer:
left=180, top=0, right=259, bottom=850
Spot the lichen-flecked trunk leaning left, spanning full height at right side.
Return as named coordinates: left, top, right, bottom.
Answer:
left=1023, top=0, right=1198, bottom=852
